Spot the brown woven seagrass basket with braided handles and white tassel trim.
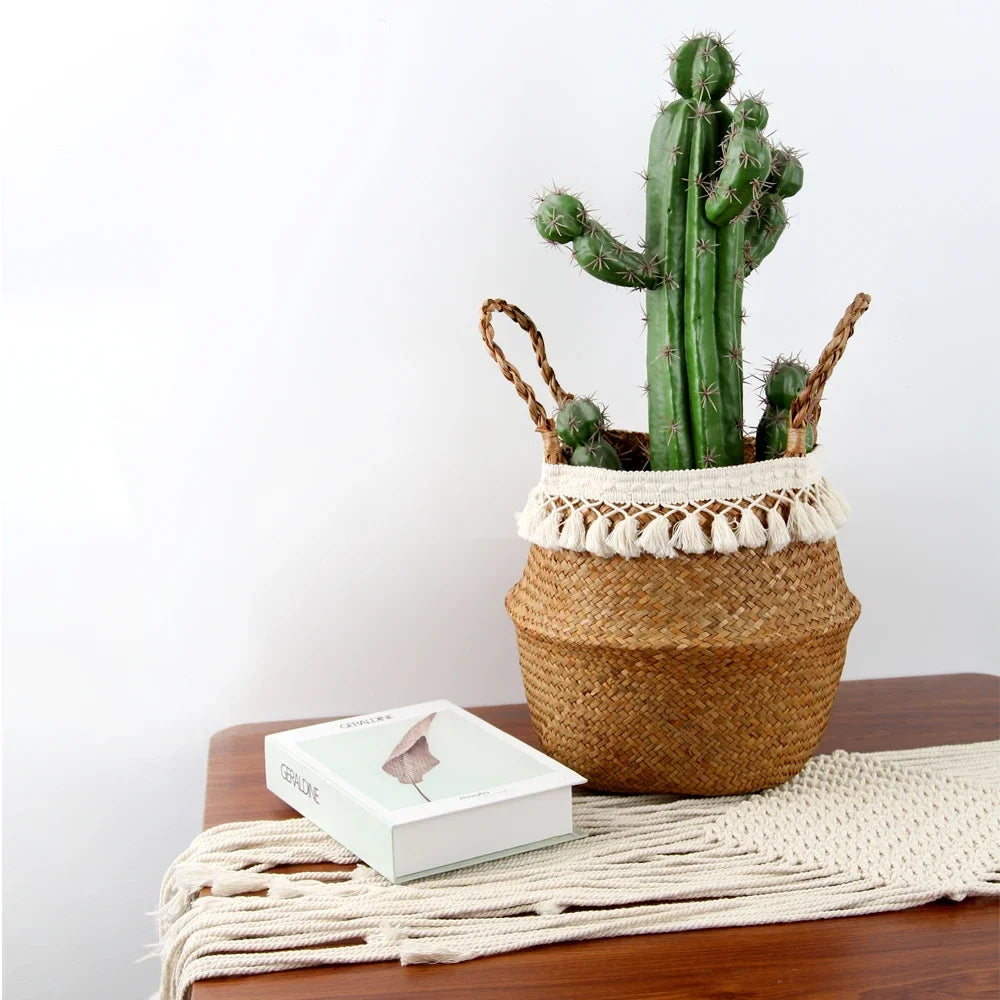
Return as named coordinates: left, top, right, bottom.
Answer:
left=481, top=295, right=869, bottom=795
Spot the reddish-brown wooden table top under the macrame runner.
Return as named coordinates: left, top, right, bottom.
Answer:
left=193, top=674, right=1000, bottom=1000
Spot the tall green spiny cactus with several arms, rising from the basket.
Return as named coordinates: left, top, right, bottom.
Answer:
left=535, top=35, right=802, bottom=469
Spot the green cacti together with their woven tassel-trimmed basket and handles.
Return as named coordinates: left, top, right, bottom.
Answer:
left=480, top=35, right=869, bottom=794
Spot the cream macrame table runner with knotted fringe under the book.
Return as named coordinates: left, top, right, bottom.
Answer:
left=156, top=742, right=1000, bottom=1000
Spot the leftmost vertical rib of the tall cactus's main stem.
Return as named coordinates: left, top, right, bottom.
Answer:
left=646, top=100, right=694, bottom=469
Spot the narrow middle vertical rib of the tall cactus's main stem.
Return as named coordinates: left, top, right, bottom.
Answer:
left=684, top=102, right=725, bottom=468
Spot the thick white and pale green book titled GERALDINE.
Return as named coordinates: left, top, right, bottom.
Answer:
left=264, top=700, right=586, bottom=882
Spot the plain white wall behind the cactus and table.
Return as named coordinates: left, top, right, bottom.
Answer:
left=0, top=0, right=1000, bottom=1000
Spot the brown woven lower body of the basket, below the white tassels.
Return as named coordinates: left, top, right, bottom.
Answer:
left=507, top=542, right=860, bottom=795
